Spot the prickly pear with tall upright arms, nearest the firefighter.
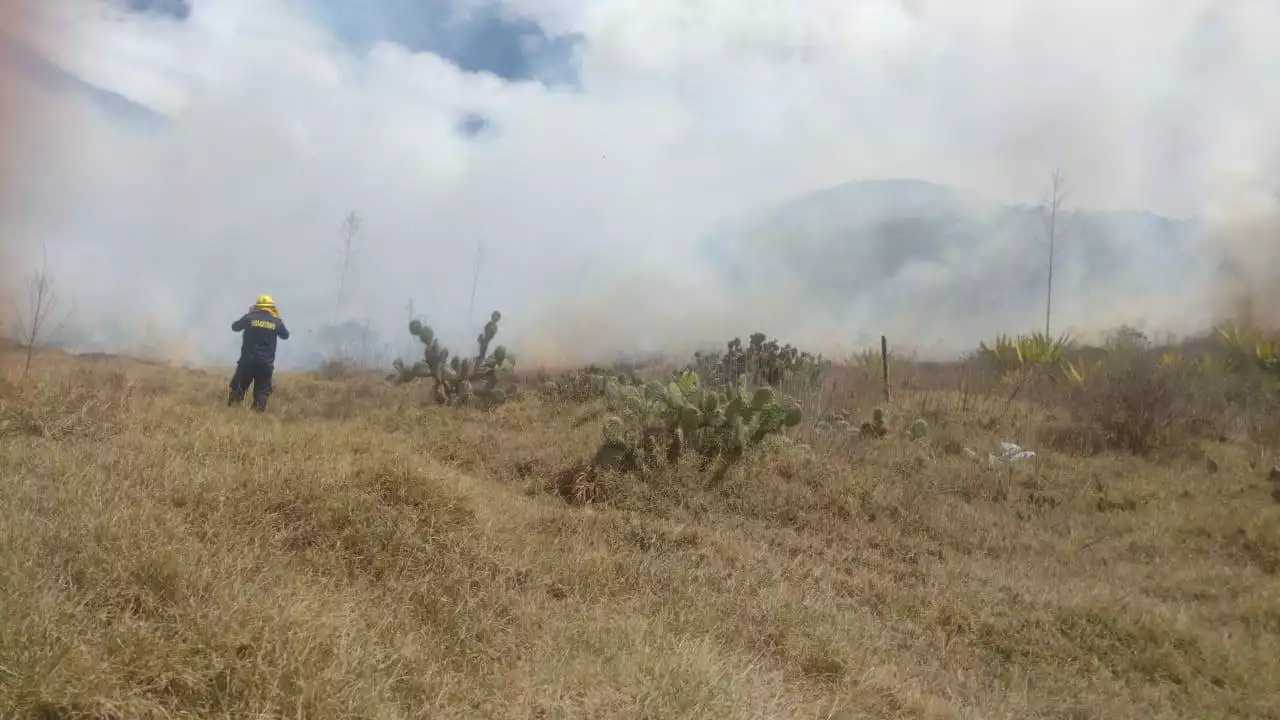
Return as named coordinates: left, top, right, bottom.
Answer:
left=387, top=310, right=520, bottom=406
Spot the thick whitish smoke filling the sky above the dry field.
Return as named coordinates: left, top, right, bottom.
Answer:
left=0, top=0, right=1280, bottom=366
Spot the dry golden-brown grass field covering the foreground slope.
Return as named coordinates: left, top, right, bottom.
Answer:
left=0, top=345, right=1280, bottom=719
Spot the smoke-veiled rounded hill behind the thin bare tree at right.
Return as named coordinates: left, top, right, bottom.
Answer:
left=705, top=179, right=1201, bottom=343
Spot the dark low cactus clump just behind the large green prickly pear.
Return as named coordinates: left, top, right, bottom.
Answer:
left=690, top=333, right=831, bottom=387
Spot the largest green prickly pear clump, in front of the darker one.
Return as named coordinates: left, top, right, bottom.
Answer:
left=595, top=370, right=803, bottom=478
